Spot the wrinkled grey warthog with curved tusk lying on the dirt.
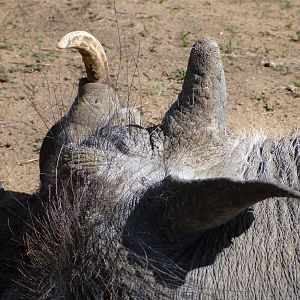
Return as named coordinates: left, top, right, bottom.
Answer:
left=3, top=31, right=300, bottom=299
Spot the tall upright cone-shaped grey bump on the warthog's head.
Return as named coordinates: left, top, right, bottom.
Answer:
left=162, top=38, right=226, bottom=149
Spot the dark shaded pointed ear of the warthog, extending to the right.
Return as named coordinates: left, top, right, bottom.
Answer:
left=150, top=177, right=300, bottom=234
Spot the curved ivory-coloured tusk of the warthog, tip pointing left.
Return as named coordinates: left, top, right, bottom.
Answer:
left=57, top=31, right=108, bottom=83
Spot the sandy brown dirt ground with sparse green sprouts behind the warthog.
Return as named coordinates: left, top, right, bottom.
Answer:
left=0, top=0, right=300, bottom=193
